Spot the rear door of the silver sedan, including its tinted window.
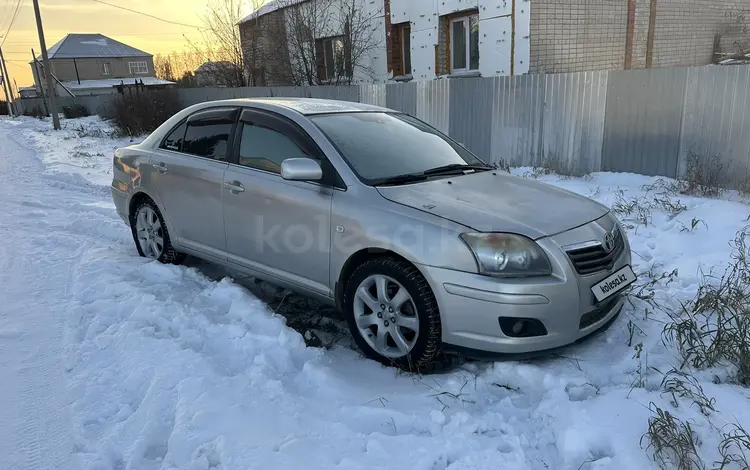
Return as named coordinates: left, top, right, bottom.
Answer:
left=151, top=107, right=239, bottom=259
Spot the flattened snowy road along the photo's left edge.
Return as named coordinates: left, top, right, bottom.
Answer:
left=0, top=123, right=80, bottom=470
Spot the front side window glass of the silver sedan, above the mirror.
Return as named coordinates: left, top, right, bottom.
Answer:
left=238, top=123, right=309, bottom=173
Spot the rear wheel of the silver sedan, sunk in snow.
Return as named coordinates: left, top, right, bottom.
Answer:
left=131, top=200, right=185, bottom=264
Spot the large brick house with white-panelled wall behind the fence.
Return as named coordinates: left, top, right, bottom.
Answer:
left=239, top=0, right=750, bottom=85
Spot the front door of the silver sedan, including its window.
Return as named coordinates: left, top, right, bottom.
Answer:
left=224, top=109, right=336, bottom=295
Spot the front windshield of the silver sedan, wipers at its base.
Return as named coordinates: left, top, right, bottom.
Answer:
left=311, top=112, right=484, bottom=184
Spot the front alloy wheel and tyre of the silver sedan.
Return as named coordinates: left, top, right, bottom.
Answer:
left=344, top=258, right=441, bottom=371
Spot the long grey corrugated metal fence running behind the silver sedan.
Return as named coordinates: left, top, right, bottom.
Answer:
left=17, top=66, right=750, bottom=186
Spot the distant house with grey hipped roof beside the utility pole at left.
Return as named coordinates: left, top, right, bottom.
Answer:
left=30, top=34, right=173, bottom=96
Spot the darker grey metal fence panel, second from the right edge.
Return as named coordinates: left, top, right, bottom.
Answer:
left=602, top=68, right=687, bottom=178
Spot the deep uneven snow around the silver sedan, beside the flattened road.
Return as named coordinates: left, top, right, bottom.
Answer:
left=5, top=114, right=750, bottom=470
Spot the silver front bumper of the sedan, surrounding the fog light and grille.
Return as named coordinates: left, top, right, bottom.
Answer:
left=420, top=217, right=631, bottom=354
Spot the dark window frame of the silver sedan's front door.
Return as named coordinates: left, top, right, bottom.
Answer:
left=227, top=107, right=347, bottom=191
